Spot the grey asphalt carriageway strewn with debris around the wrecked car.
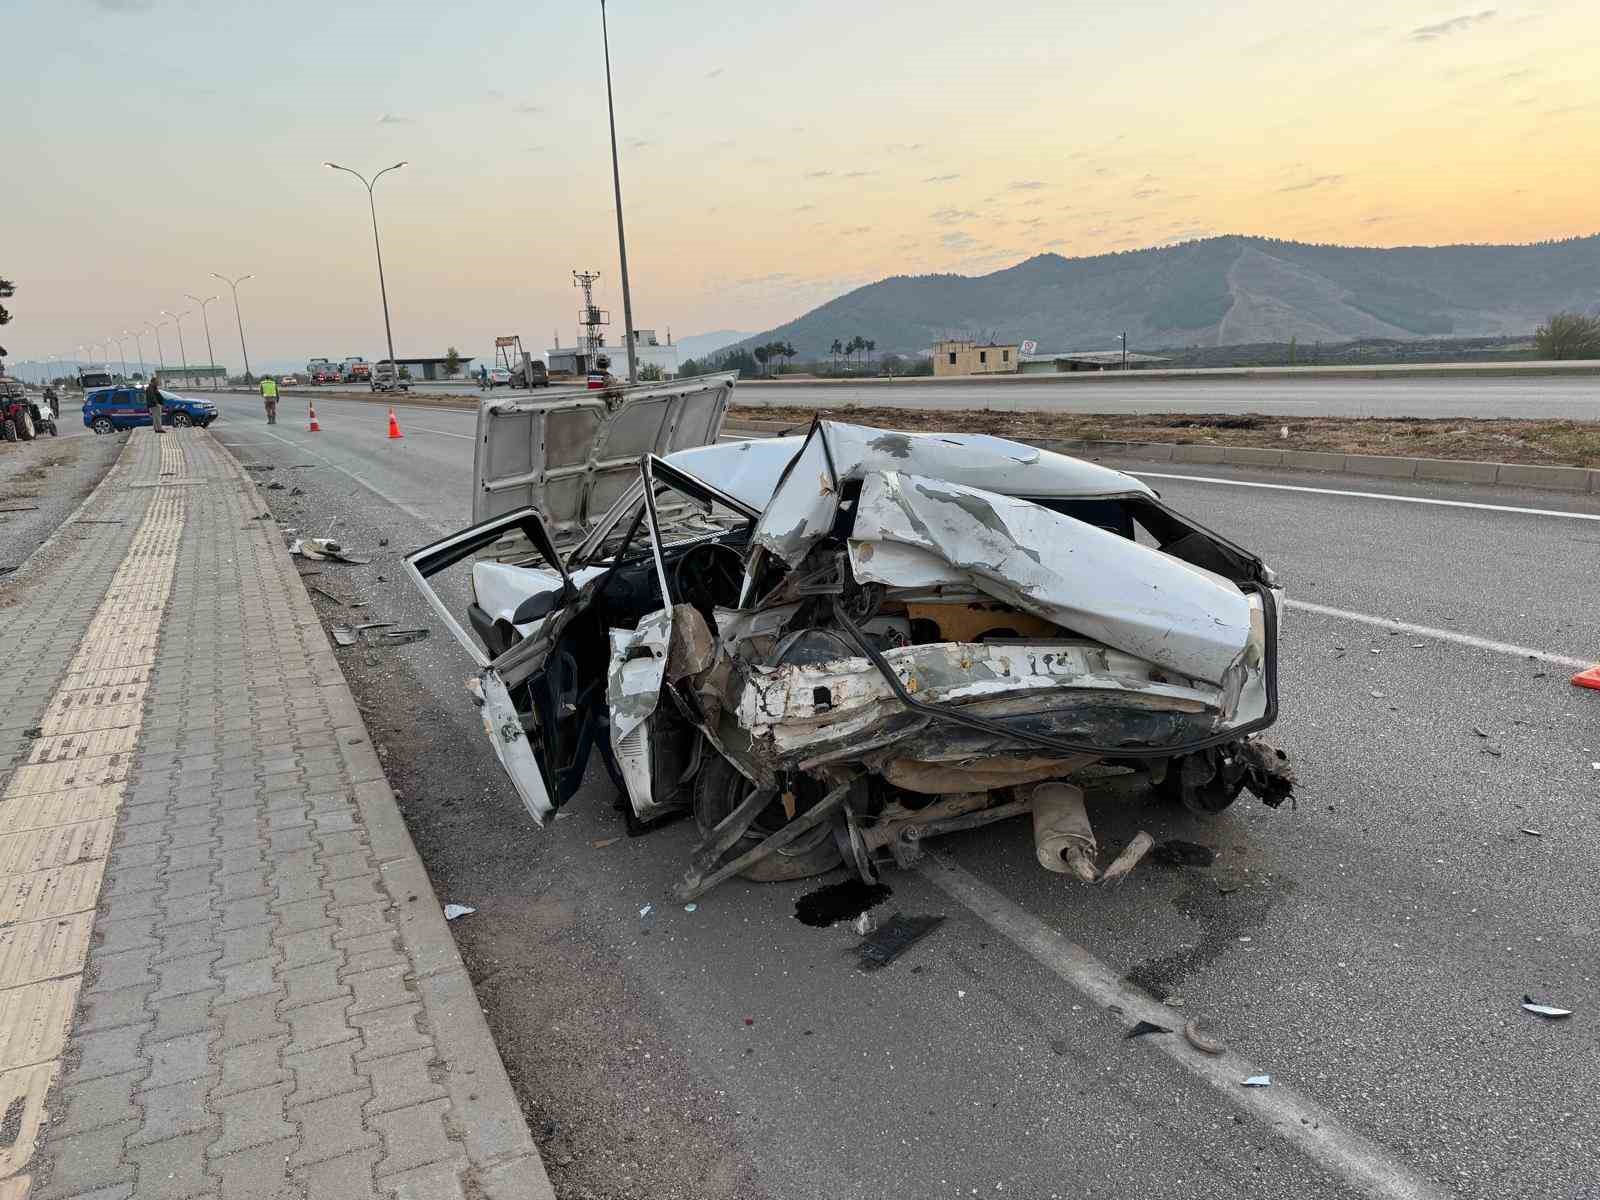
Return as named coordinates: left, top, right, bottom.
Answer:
left=213, top=384, right=1600, bottom=1200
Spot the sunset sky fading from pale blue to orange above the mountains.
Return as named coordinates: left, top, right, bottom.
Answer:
left=12, top=0, right=1600, bottom=370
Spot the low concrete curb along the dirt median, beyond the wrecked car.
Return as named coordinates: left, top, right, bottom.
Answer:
left=730, top=419, right=1600, bottom=494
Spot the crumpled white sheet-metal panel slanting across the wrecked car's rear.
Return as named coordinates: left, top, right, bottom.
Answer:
left=851, top=472, right=1264, bottom=690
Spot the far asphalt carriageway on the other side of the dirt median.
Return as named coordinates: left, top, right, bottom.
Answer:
left=739, top=376, right=1600, bottom=421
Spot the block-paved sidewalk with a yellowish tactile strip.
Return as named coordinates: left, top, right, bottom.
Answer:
left=0, top=430, right=552, bottom=1200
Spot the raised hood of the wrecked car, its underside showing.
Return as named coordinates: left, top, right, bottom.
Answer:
left=472, top=373, right=738, bottom=546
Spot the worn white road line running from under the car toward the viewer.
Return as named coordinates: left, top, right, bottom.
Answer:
left=918, top=854, right=1448, bottom=1200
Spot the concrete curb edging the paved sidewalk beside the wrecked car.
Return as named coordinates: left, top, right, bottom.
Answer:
left=219, top=430, right=555, bottom=1200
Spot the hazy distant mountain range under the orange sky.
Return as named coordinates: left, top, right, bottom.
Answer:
left=729, top=235, right=1600, bottom=358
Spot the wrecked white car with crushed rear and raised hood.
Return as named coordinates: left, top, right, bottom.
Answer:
left=406, top=376, right=1293, bottom=896
